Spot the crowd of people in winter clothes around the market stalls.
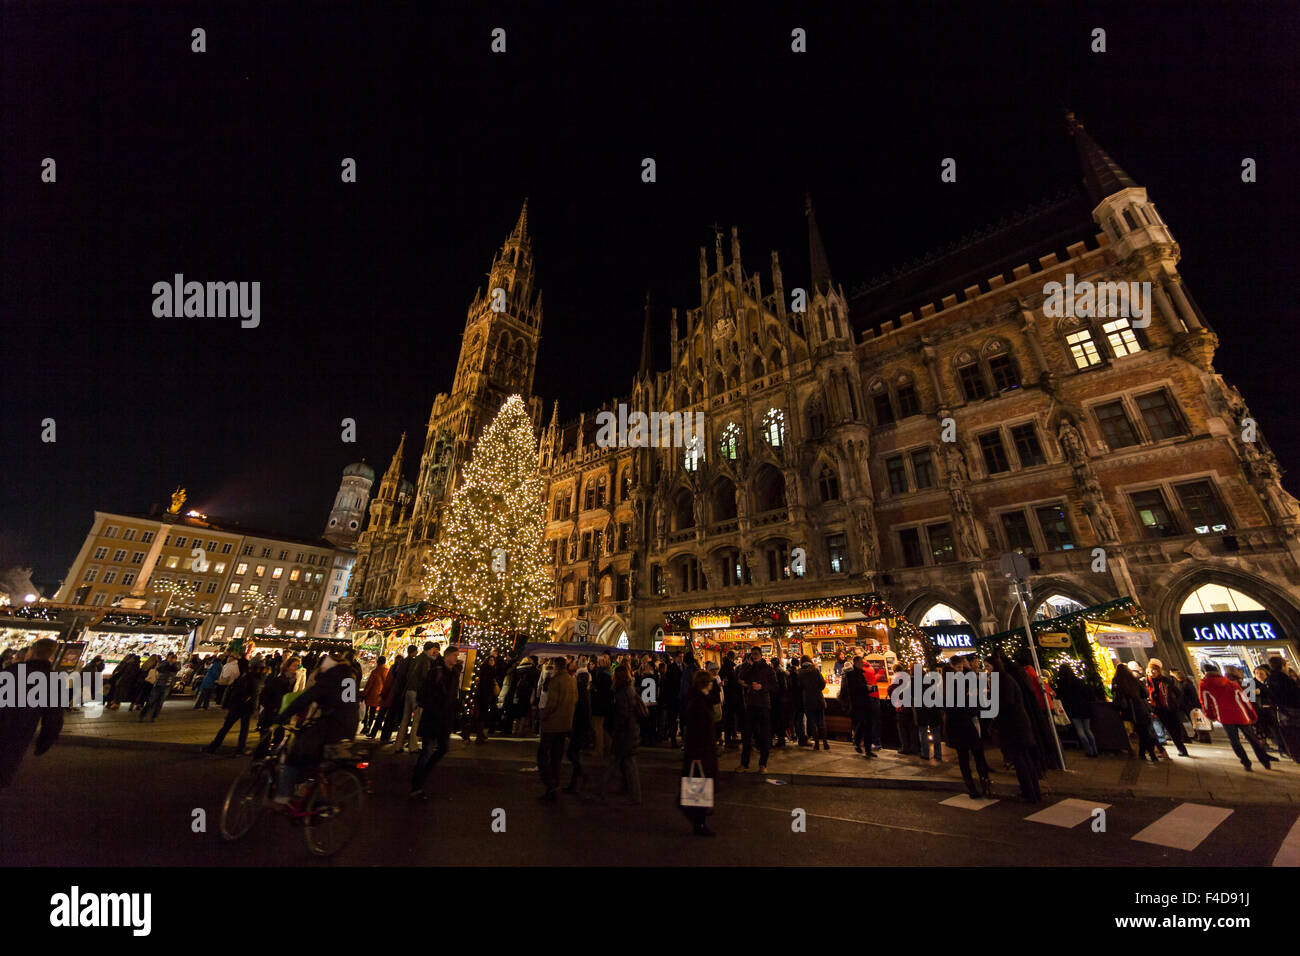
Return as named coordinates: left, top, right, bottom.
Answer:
left=0, top=641, right=1300, bottom=835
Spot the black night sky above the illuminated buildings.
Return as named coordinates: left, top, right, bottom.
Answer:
left=0, top=0, right=1300, bottom=583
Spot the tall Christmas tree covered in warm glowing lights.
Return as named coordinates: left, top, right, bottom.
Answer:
left=424, top=395, right=553, bottom=639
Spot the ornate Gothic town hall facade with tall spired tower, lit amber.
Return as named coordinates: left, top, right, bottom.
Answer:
left=348, top=117, right=1300, bottom=676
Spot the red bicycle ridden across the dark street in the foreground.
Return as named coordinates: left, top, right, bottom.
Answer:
left=221, top=721, right=369, bottom=856
